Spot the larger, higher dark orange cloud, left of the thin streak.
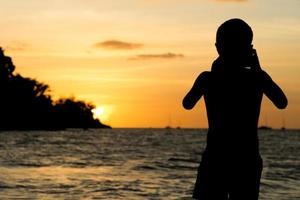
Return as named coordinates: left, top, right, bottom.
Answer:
left=94, top=40, right=143, bottom=50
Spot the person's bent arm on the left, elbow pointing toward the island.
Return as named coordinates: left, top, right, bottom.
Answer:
left=182, top=72, right=210, bottom=110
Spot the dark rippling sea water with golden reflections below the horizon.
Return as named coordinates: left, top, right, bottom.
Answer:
left=0, top=129, right=300, bottom=200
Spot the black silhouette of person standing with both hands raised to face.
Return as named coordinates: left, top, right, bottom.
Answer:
left=182, top=19, right=287, bottom=200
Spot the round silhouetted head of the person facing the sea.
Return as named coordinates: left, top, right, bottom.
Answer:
left=216, top=19, right=253, bottom=60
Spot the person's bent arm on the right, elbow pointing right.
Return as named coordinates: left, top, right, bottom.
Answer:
left=262, top=71, right=288, bottom=109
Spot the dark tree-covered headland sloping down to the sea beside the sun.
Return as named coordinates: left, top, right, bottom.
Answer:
left=0, top=47, right=110, bottom=130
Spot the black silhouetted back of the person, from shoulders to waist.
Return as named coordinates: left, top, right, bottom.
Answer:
left=204, top=71, right=262, bottom=155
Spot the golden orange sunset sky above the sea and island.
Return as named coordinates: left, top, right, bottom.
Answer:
left=0, top=0, right=300, bottom=128
